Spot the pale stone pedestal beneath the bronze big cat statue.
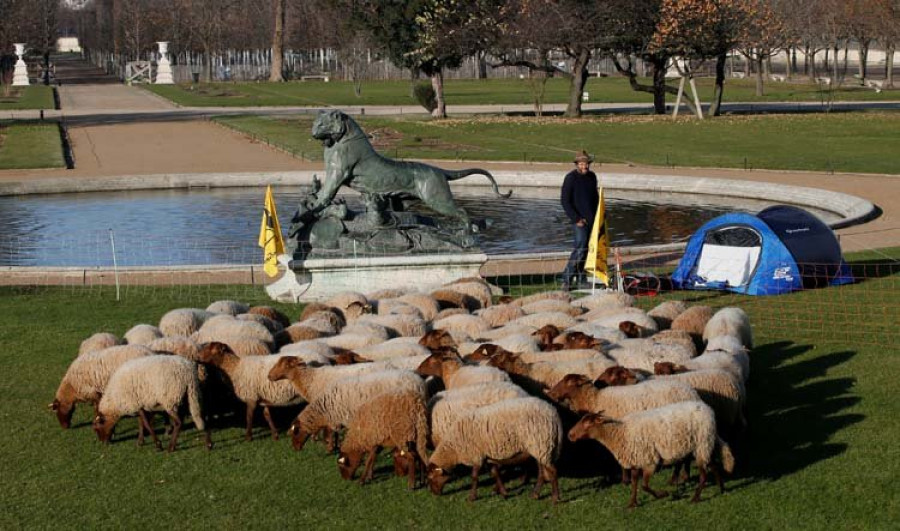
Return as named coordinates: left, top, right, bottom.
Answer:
left=266, top=253, right=487, bottom=302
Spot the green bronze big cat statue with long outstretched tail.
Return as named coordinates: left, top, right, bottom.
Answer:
left=312, top=110, right=512, bottom=231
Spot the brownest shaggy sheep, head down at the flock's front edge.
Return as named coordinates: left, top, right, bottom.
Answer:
left=338, top=391, right=428, bottom=489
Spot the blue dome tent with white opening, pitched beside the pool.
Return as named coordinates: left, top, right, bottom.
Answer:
left=672, top=205, right=853, bottom=295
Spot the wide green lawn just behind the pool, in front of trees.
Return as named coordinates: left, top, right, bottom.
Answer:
left=217, top=112, right=900, bottom=174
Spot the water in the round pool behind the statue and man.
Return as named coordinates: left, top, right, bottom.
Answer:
left=0, top=187, right=828, bottom=267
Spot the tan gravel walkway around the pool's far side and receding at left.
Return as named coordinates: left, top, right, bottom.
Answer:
left=0, top=84, right=900, bottom=256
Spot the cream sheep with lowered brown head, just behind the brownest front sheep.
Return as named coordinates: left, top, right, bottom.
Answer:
left=291, top=370, right=425, bottom=451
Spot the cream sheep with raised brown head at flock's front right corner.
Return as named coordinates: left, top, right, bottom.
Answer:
left=569, top=401, right=734, bottom=508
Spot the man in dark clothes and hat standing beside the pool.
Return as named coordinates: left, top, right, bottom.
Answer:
left=560, top=150, right=600, bottom=290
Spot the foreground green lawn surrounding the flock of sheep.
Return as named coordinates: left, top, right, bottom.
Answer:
left=0, top=250, right=900, bottom=530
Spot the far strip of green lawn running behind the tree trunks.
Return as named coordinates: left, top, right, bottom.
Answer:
left=144, top=77, right=900, bottom=107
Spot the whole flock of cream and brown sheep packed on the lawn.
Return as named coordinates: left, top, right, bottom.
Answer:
left=50, top=278, right=753, bottom=507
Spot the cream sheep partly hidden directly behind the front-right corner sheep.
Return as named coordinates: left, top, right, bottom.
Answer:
left=547, top=374, right=700, bottom=418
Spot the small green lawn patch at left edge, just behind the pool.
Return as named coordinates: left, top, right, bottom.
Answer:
left=0, top=122, right=66, bottom=170
